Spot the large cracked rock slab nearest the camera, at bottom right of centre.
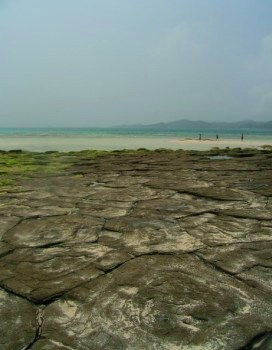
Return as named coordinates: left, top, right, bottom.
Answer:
left=30, top=254, right=271, bottom=350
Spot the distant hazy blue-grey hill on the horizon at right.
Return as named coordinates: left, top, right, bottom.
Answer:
left=123, top=119, right=272, bottom=130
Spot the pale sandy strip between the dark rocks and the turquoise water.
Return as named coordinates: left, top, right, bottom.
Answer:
left=0, top=136, right=272, bottom=152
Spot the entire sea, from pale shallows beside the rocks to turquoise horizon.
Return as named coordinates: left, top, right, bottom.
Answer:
left=0, top=127, right=272, bottom=151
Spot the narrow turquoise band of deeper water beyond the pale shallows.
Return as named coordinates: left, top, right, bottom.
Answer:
left=0, top=128, right=272, bottom=140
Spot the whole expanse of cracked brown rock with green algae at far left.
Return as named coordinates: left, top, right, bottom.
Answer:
left=0, top=150, right=272, bottom=350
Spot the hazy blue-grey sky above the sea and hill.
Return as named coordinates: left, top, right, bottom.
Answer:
left=0, top=0, right=272, bottom=127
